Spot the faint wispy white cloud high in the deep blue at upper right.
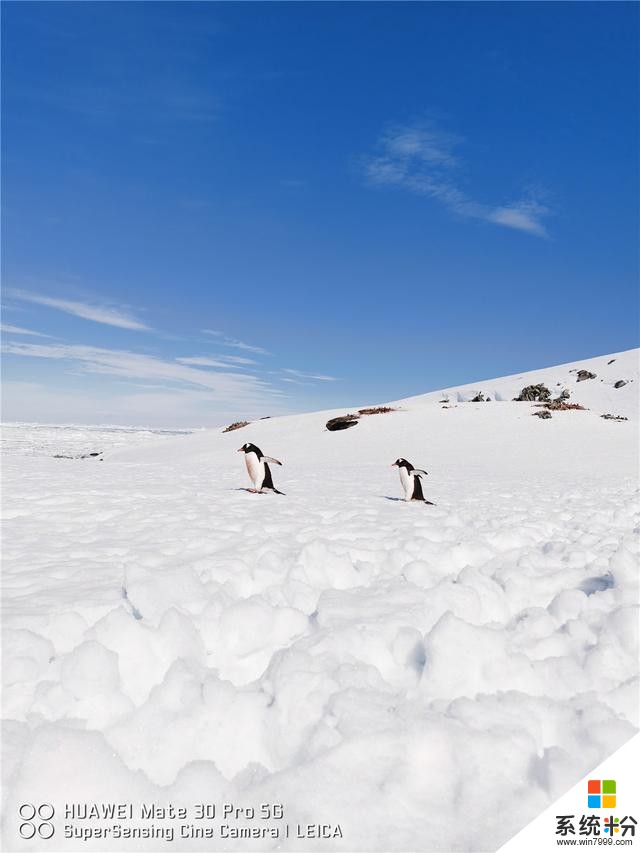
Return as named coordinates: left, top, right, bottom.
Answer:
left=363, top=124, right=550, bottom=237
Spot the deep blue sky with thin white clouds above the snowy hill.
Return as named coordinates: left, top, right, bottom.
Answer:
left=2, top=2, right=639, bottom=426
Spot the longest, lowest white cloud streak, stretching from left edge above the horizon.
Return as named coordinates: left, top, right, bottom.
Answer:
left=2, top=342, right=280, bottom=402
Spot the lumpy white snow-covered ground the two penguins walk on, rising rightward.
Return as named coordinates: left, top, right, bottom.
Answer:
left=2, top=351, right=640, bottom=851
